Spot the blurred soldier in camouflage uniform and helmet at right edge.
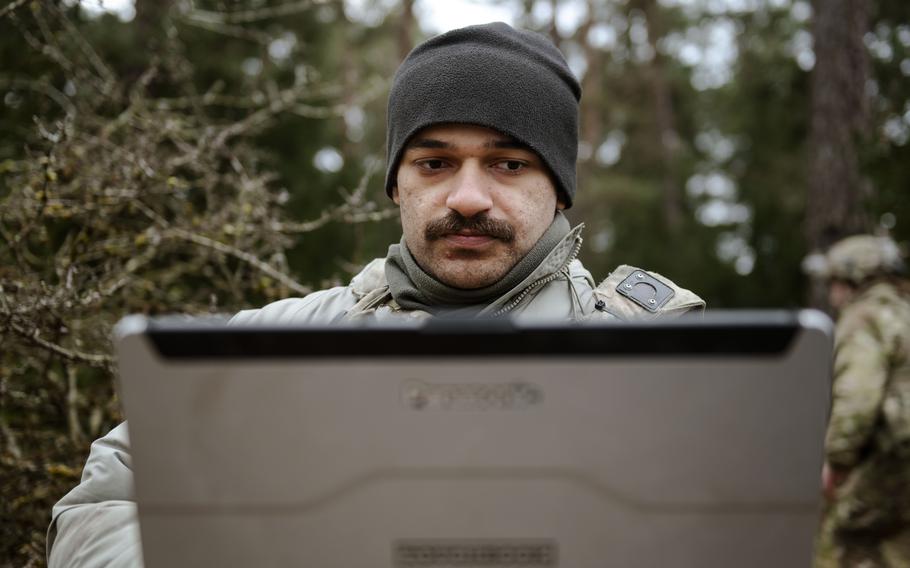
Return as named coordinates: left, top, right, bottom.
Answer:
left=816, top=235, right=910, bottom=567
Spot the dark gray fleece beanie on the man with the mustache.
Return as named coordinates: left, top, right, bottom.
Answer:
left=385, top=22, right=581, bottom=208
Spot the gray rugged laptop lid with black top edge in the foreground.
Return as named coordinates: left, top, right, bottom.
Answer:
left=117, top=311, right=831, bottom=568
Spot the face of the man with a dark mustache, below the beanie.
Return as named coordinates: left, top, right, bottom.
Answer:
left=392, top=124, right=563, bottom=289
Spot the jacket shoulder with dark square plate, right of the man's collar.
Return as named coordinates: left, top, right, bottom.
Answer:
left=594, top=264, right=705, bottom=320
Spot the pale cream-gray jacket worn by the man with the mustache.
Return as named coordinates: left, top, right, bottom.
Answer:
left=47, top=228, right=705, bottom=568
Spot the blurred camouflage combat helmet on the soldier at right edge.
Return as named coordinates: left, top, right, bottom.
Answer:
left=804, top=235, right=906, bottom=285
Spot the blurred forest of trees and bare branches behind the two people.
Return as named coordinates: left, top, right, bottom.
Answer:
left=0, top=0, right=910, bottom=566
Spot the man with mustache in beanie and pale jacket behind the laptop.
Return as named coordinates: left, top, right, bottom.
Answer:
left=48, top=23, right=704, bottom=566
